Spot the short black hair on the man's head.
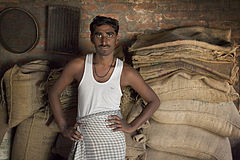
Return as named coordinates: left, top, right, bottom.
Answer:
left=90, top=16, right=119, bottom=35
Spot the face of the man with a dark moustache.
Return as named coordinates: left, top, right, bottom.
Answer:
left=91, top=25, right=118, bottom=56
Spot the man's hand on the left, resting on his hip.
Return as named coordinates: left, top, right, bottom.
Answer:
left=62, top=123, right=83, bottom=141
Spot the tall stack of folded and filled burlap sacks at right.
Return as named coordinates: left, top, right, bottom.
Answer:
left=126, top=27, right=240, bottom=160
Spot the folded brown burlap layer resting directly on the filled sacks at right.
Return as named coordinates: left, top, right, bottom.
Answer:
left=139, top=58, right=239, bottom=84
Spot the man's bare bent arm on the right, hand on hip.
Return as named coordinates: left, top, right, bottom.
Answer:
left=109, top=64, right=160, bottom=133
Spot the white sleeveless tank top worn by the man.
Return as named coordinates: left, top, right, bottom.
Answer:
left=78, top=54, right=123, bottom=117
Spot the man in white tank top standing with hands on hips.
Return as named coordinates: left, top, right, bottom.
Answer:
left=49, top=16, right=160, bottom=160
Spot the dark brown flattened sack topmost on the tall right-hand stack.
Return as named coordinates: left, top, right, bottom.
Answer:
left=129, top=27, right=231, bottom=51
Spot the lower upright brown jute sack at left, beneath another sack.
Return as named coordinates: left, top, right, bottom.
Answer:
left=11, top=112, right=58, bottom=160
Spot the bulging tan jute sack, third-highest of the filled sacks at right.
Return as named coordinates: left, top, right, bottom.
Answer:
left=144, top=120, right=232, bottom=160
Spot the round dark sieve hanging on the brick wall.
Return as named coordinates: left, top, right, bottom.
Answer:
left=0, top=8, right=39, bottom=53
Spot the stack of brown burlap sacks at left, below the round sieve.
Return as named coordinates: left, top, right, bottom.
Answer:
left=0, top=60, right=61, bottom=160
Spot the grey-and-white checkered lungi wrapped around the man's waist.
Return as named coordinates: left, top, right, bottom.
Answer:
left=68, top=110, right=126, bottom=160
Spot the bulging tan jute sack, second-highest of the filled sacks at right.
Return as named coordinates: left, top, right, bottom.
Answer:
left=152, top=100, right=240, bottom=138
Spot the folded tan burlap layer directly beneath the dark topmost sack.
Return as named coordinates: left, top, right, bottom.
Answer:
left=132, top=40, right=238, bottom=66
